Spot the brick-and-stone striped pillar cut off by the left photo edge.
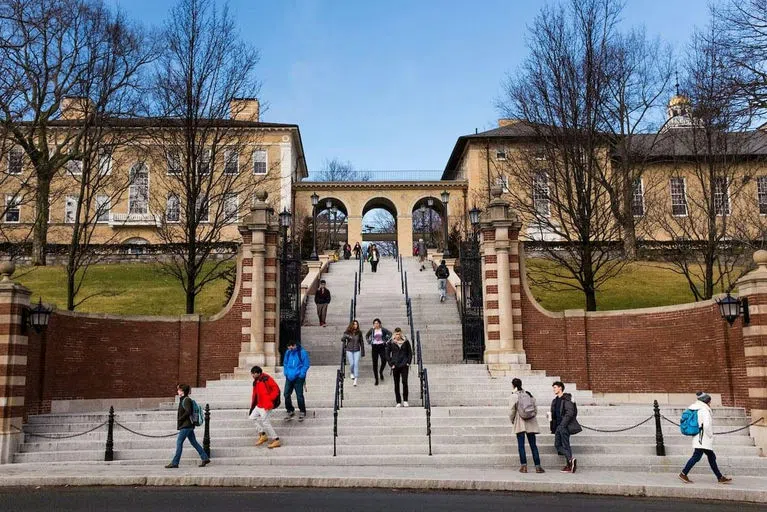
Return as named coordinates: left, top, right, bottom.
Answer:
left=0, top=262, right=30, bottom=464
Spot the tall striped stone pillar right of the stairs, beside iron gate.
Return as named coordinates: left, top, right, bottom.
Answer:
left=480, top=187, right=526, bottom=373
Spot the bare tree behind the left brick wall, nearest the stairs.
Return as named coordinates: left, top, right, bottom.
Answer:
left=150, top=0, right=273, bottom=313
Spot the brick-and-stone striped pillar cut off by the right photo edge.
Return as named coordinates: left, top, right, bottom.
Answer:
left=738, top=251, right=767, bottom=455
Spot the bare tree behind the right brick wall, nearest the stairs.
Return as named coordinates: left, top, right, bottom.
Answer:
left=499, top=0, right=624, bottom=311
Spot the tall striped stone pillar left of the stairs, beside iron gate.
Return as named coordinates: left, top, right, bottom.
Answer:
left=239, top=191, right=278, bottom=370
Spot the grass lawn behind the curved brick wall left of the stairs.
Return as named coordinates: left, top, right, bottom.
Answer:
left=13, top=263, right=233, bottom=315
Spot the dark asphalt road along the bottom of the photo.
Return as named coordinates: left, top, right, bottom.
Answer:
left=0, top=487, right=764, bottom=512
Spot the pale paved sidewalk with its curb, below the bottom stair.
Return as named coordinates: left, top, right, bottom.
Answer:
left=0, top=460, right=767, bottom=503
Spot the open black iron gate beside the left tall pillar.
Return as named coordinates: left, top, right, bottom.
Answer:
left=279, top=243, right=301, bottom=364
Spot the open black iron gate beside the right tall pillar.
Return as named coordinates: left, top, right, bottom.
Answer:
left=459, top=240, right=485, bottom=363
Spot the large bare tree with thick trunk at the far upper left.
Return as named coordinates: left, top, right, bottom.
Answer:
left=0, top=0, right=152, bottom=265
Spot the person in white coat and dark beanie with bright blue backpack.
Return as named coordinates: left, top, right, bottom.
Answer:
left=679, top=391, right=732, bottom=484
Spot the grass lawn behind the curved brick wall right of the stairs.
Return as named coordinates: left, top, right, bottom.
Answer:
left=526, top=258, right=716, bottom=311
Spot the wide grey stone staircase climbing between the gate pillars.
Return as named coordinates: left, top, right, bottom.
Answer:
left=14, top=258, right=767, bottom=476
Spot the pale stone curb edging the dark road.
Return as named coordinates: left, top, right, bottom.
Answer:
left=0, top=475, right=767, bottom=503
